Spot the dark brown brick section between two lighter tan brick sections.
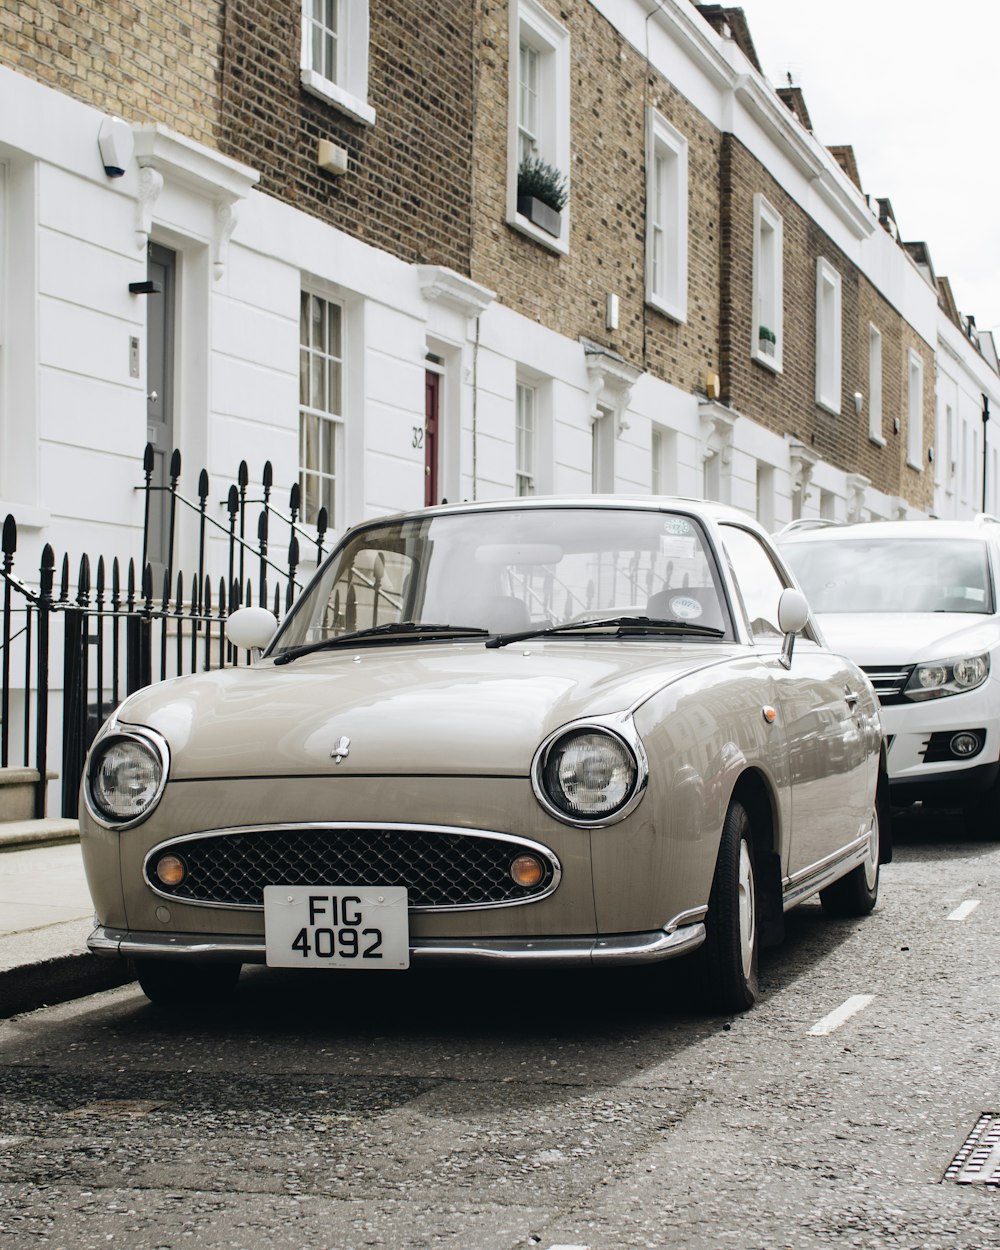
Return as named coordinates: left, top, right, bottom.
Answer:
left=220, top=0, right=474, bottom=273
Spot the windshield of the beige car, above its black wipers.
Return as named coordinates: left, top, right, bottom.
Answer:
left=269, top=506, right=728, bottom=656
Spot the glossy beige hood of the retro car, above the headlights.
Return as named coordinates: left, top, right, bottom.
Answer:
left=118, top=639, right=740, bottom=780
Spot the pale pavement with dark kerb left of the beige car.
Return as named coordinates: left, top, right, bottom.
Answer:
left=0, top=820, right=133, bottom=1019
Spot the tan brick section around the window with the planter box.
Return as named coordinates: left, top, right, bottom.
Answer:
left=471, top=0, right=720, bottom=390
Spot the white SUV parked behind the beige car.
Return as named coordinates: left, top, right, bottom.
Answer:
left=776, top=516, right=1000, bottom=834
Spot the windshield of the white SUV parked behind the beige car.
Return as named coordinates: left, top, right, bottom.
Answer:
left=781, top=535, right=993, bottom=613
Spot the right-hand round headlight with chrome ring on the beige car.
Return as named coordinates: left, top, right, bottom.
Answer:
left=531, top=723, right=648, bottom=825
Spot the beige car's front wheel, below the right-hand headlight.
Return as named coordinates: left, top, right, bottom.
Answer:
left=696, top=799, right=760, bottom=1015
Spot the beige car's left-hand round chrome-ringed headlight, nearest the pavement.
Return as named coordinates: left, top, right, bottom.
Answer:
left=84, top=729, right=169, bottom=829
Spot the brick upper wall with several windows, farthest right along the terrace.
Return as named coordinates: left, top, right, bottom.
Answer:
left=721, top=135, right=934, bottom=509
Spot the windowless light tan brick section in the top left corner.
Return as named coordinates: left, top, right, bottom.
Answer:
left=0, top=0, right=223, bottom=145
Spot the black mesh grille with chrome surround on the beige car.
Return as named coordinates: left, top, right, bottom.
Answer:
left=146, top=826, right=560, bottom=909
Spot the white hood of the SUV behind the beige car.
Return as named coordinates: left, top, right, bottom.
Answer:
left=819, top=613, right=1000, bottom=666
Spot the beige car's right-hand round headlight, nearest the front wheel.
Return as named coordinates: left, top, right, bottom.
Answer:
left=541, top=729, right=639, bottom=820
